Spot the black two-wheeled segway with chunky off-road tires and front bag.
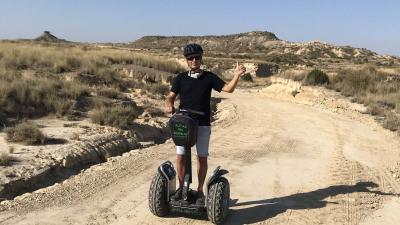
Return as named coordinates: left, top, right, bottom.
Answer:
left=149, top=109, right=230, bottom=224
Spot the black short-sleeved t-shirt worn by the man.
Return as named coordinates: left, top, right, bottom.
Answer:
left=171, top=71, right=225, bottom=126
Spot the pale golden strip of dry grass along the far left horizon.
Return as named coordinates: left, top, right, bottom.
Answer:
left=0, top=42, right=182, bottom=73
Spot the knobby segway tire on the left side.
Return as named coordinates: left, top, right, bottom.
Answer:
left=149, top=173, right=169, bottom=217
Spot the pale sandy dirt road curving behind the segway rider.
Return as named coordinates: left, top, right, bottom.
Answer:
left=0, top=90, right=400, bottom=225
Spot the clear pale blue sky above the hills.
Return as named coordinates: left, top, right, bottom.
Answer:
left=0, top=0, right=400, bottom=56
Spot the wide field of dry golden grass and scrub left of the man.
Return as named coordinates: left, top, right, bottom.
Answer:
left=0, top=41, right=182, bottom=129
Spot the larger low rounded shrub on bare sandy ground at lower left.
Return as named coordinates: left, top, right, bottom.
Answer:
left=5, top=122, right=46, bottom=145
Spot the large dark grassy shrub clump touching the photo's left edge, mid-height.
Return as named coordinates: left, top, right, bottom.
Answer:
left=0, top=78, right=89, bottom=118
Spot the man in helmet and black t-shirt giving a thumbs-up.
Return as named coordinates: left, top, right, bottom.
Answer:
left=165, top=44, right=246, bottom=204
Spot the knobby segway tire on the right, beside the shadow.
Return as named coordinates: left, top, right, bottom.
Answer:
left=206, top=177, right=230, bottom=224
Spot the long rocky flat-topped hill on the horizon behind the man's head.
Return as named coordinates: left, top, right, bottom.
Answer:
left=128, top=31, right=400, bottom=65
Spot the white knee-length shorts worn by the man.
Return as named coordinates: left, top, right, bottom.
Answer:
left=176, top=126, right=211, bottom=157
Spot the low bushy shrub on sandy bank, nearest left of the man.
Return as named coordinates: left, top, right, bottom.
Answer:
left=91, top=102, right=142, bottom=129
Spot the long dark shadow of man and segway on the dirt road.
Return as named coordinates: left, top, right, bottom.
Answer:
left=225, top=182, right=398, bottom=224
